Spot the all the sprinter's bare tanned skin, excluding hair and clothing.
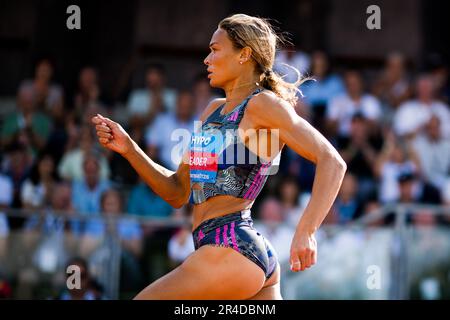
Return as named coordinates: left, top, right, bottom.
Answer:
left=92, top=29, right=346, bottom=299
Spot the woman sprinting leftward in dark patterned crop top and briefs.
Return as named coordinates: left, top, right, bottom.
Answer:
left=92, top=14, right=346, bottom=299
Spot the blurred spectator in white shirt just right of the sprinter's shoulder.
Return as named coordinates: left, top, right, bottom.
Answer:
left=326, top=70, right=381, bottom=138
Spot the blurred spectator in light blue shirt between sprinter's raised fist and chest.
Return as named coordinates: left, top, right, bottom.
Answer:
left=145, top=91, right=194, bottom=170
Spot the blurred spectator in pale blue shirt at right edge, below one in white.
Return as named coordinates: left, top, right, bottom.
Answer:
left=413, top=115, right=450, bottom=190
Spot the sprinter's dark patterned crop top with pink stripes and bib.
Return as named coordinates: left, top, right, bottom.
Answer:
left=189, top=88, right=281, bottom=204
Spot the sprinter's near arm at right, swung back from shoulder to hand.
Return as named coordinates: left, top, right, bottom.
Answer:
left=247, top=92, right=347, bottom=271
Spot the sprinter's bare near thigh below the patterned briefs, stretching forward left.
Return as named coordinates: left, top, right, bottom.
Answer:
left=135, top=245, right=265, bottom=300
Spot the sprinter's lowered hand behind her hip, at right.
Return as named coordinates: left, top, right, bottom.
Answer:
left=290, top=230, right=317, bottom=272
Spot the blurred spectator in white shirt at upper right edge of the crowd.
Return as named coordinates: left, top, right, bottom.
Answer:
left=393, top=75, right=450, bottom=139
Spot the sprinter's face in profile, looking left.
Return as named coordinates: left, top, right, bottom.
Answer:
left=204, top=28, right=242, bottom=88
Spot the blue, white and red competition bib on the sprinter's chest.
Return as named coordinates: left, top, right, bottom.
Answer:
left=189, top=130, right=222, bottom=183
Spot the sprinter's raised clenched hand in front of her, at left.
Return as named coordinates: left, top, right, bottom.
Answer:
left=92, top=114, right=133, bottom=155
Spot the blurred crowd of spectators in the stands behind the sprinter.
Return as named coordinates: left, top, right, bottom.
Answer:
left=0, top=48, right=450, bottom=299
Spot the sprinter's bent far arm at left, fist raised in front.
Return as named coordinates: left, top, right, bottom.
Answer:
left=92, top=99, right=225, bottom=208
